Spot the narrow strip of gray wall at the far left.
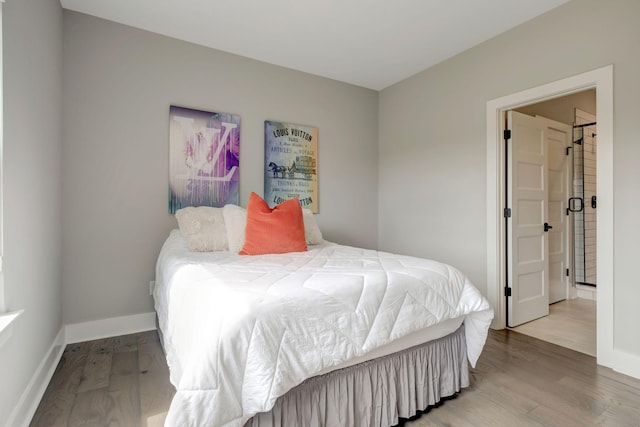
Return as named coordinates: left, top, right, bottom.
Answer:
left=0, top=0, right=62, bottom=425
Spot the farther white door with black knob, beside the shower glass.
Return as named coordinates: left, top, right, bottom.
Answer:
left=536, top=116, right=573, bottom=304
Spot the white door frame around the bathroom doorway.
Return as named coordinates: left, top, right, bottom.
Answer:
left=486, top=65, right=616, bottom=367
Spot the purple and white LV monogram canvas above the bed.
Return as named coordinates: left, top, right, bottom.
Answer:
left=169, top=105, right=240, bottom=213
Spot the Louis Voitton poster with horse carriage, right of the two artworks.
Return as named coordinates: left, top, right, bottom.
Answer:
left=264, top=120, right=318, bottom=213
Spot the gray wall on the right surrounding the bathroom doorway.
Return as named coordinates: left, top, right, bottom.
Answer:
left=378, top=0, right=640, bottom=355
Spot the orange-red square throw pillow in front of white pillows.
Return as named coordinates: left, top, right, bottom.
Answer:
left=240, top=193, right=307, bottom=255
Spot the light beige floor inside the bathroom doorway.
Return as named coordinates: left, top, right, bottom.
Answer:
left=512, top=298, right=596, bottom=356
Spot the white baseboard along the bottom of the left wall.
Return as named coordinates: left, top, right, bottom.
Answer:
left=6, top=327, right=65, bottom=427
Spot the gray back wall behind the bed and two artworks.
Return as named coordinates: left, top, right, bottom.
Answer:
left=62, top=11, right=378, bottom=323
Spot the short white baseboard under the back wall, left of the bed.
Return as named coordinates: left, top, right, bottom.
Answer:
left=65, top=313, right=156, bottom=344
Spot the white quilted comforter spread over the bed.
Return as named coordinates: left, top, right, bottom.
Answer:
left=154, top=230, right=493, bottom=427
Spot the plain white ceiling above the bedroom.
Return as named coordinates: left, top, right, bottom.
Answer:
left=60, top=0, right=568, bottom=90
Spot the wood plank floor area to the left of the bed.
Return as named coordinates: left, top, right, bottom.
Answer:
left=30, top=331, right=175, bottom=427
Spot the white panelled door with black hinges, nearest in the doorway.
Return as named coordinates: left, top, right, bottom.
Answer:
left=507, top=111, right=549, bottom=327
